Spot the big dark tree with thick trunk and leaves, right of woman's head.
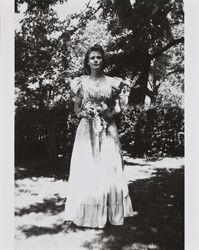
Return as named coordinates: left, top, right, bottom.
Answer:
left=98, top=0, right=184, bottom=105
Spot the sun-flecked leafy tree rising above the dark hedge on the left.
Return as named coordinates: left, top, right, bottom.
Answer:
left=15, top=6, right=75, bottom=109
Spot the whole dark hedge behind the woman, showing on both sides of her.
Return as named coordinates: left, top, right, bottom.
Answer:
left=15, top=103, right=184, bottom=165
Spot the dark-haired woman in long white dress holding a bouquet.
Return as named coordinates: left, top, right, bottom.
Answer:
left=65, top=45, right=134, bottom=228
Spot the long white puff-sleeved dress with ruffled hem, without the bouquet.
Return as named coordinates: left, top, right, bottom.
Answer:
left=65, top=76, right=134, bottom=228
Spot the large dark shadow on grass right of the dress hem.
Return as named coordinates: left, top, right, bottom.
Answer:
left=84, top=168, right=184, bottom=250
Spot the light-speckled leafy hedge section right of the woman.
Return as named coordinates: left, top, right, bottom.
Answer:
left=119, top=105, right=184, bottom=157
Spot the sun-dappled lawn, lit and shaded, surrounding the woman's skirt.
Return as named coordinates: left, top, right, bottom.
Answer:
left=15, top=157, right=184, bottom=250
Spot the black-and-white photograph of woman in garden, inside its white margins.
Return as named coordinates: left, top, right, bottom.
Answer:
left=3, top=0, right=197, bottom=250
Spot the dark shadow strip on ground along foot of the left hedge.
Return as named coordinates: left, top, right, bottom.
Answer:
left=15, top=157, right=70, bottom=180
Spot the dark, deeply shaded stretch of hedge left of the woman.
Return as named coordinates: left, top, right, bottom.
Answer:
left=15, top=98, right=78, bottom=163
